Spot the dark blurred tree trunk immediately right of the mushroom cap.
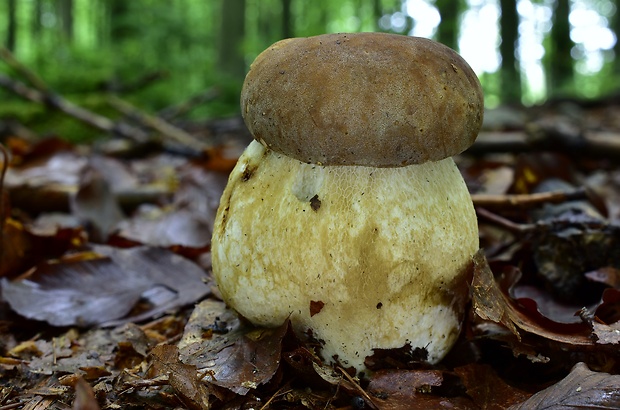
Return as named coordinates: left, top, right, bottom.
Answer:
left=499, top=0, right=521, bottom=103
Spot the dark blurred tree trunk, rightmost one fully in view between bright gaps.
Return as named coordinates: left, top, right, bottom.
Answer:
left=545, top=0, right=575, bottom=95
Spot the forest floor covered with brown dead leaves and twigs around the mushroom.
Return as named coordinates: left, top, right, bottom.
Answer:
left=0, top=99, right=620, bottom=410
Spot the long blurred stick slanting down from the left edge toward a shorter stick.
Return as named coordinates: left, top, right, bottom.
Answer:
left=0, top=75, right=149, bottom=143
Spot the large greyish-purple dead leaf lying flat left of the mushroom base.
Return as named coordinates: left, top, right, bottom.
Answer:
left=2, top=246, right=209, bottom=326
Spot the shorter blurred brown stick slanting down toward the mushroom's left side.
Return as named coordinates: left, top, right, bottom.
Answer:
left=108, top=95, right=207, bottom=152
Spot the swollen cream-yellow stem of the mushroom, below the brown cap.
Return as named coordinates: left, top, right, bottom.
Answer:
left=212, top=141, right=478, bottom=371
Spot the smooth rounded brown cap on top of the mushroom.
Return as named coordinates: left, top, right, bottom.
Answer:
left=241, top=33, right=483, bottom=167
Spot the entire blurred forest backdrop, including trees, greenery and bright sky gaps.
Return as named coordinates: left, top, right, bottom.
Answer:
left=0, top=0, right=620, bottom=139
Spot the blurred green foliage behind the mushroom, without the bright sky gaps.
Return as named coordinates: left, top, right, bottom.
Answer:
left=0, top=0, right=618, bottom=140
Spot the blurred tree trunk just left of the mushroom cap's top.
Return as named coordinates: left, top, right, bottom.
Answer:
left=218, top=0, right=245, bottom=79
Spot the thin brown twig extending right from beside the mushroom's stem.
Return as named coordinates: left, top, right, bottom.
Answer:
left=471, top=188, right=587, bottom=208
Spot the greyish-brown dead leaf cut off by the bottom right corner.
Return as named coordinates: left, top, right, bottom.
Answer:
left=510, top=363, right=620, bottom=410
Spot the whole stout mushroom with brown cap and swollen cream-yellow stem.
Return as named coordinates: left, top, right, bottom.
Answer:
left=212, top=33, right=483, bottom=371
